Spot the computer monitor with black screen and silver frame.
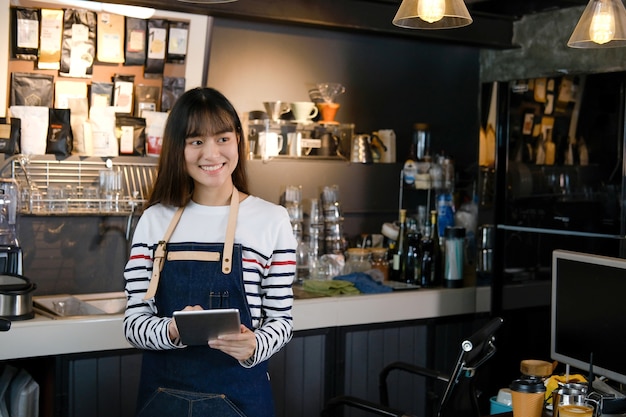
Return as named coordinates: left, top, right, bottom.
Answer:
left=550, top=250, right=626, bottom=384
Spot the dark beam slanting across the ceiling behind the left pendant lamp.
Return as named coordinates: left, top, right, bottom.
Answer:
left=113, top=0, right=517, bottom=49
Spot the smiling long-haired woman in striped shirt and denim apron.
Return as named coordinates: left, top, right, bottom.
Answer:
left=124, top=88, right=296, bottom=417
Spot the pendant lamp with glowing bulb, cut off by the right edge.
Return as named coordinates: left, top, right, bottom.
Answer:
left=567, top=0, right=626, bottom=48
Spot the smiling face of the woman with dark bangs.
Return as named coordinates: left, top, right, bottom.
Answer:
left=185, top=132, right=239, bottom=194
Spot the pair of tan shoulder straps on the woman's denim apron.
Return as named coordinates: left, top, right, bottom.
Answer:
left=143, top=187, right=239, bottom=300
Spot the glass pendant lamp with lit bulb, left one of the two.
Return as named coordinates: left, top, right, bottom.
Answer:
left=393, top=0, right=472, bottom=29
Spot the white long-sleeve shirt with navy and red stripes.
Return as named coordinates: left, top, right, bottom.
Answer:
left=124, top=196, right=296, bottom=367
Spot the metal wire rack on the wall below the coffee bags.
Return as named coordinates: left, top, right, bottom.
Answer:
left=0, top=155, right=157, bottom=215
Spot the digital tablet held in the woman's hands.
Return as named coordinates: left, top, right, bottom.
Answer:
left=174, top=308, right=241, bottom=346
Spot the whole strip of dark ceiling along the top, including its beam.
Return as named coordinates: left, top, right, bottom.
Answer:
left=116, top=0, right=589, bottom=49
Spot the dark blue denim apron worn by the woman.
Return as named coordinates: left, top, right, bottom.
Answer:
left=138, top=189, right=274, bottom=417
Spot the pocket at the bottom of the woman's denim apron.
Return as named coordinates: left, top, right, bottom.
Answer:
left=137, top=388, right=246, bottom=417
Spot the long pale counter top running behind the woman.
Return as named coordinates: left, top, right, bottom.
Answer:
left=0, top=287, right=491, bottom=360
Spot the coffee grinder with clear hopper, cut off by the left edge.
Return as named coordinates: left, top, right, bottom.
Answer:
left=0, top=178, right=23, bottom=275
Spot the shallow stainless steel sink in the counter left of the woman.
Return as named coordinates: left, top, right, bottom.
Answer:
left=33, top=292, right=126, bottom=318
